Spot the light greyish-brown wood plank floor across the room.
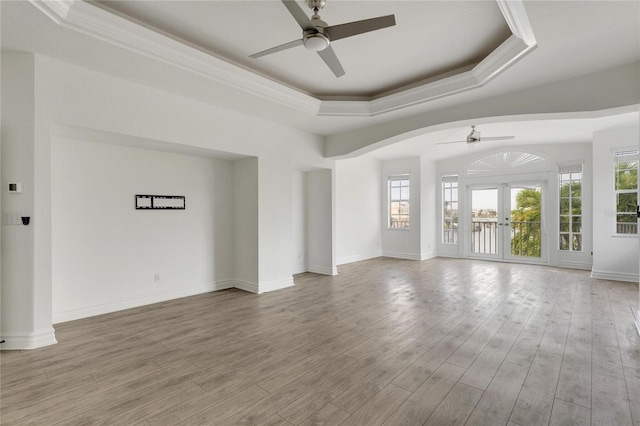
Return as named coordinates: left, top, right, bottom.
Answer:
left=1, top=258, right=640, bottom=426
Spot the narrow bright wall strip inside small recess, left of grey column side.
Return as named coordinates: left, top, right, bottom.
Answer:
left=291, top=170, right=307, bottom=274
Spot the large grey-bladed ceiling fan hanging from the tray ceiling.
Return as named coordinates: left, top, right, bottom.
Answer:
left=249, top=0, right=396, bottom=77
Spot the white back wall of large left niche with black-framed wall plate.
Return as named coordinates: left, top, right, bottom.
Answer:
left=51, top=138, right=234, bottom=323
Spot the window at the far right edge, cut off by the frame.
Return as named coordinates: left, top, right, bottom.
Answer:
left=614, top=149, right=638, bottom=234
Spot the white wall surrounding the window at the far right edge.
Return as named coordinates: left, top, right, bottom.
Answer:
left=592, top=126, right=640, bottom=282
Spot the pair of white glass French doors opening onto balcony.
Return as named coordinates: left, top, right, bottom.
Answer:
left=467, top=182, right=544, bottom=262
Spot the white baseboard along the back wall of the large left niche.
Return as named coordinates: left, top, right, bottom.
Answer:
left=53, top=280, right=235, bottom=324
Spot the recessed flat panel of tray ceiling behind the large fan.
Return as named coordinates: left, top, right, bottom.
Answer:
left=98, top=0, right=511, bottom=99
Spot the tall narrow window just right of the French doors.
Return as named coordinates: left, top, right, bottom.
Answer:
left=558, top=164, right=582, bottom=251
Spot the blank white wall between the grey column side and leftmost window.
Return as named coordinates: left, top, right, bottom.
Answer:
left=335, top=158, right=382, bottom=265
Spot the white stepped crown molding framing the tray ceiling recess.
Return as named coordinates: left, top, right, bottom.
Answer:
left=29, top=0, right=537, bottom=117
